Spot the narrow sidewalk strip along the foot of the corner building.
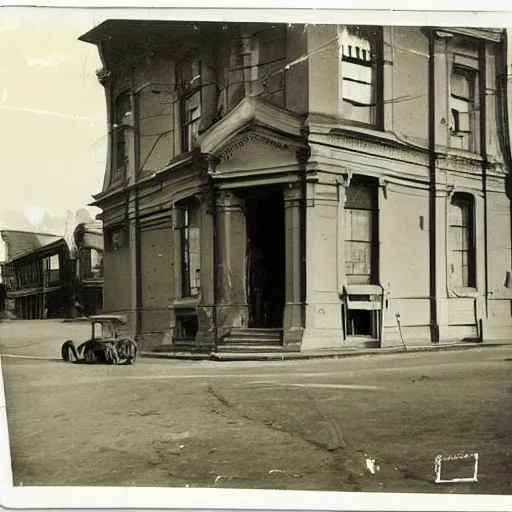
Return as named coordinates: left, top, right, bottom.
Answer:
left=141, top=341, right=509, bottom=361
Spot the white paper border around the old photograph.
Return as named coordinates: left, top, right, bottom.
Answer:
left=0, top=0, right=512, bottom=512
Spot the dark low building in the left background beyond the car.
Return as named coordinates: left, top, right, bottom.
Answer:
left=1, top=223, right=103, bottom=320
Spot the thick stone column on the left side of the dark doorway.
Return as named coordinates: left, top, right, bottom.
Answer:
left=216, top=191, right=249, bottom=340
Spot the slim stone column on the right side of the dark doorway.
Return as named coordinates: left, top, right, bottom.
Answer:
left=283, top=183, right=304, bottom=351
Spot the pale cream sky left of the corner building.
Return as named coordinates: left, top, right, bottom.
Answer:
left=0, top=9, right=107, bottom=229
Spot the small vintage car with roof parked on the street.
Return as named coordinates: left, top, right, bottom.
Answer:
left=61, top=315, right=138, bottom=364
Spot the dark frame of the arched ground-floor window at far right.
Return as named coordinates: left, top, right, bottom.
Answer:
left=448, top=191, right=478, bottom=291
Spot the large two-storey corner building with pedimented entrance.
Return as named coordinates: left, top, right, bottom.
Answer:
left=81, top=20, right=512, bottom=351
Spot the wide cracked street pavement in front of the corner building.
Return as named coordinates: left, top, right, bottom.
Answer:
left=0, top=322, right=512, bottom=494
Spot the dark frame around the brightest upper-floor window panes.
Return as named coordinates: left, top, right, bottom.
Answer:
left=338, top=25, right=384, bottom=130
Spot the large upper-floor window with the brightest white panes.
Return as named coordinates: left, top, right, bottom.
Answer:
left=339, top=26, right=382, bottom=126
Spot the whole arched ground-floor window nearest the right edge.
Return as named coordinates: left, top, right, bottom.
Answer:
left=449, top=193, right=476, bottom=288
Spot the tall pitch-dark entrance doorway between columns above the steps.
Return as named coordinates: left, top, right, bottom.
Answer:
left=245, top=188, right=285, bottom=329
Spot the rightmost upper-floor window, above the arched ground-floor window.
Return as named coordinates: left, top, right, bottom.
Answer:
left=450, top=66, right=478, bottom=152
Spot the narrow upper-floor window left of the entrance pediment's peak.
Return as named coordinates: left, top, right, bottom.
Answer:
left=176, top=56, right=201, bottom=152
